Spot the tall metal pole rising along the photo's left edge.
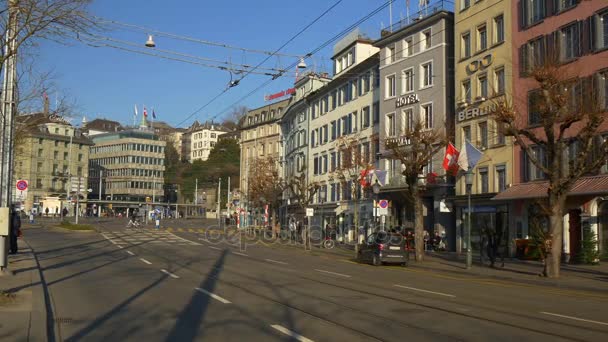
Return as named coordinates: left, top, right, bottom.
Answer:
left=0, top=0, right=18, bottom=273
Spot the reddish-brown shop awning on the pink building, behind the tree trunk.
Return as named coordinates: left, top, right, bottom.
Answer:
left=492, top=175, right=608, bottom=200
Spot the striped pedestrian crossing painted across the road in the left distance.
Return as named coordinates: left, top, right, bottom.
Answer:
left=101, top=228, right=201, bottom=248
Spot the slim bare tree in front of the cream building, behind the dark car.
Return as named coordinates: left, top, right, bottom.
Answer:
left=331, top=135, right=376, bottom=255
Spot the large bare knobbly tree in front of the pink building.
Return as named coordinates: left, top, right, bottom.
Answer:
left=493, top=58, right=608, bottom=277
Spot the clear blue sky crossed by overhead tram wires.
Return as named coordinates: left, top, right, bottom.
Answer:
left=39, top=0, right=435, bottom=127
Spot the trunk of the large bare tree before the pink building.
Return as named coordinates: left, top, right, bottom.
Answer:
left=543, top=194, right=565, bottom=278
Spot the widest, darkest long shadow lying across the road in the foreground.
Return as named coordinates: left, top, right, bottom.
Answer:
left=165, top=249, right=228, bottom=341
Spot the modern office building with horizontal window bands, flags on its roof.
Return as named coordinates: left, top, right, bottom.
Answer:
left=89, top=127, right=166, bottom=211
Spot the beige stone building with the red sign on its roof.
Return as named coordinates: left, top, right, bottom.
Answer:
left=239, top=98, right=291, bottom=215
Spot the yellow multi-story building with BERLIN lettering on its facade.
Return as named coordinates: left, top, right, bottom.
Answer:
left=453, top=0, right=515, bottom=251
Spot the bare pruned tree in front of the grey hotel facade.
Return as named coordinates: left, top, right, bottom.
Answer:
left=386, top=120, right=447, bottom=261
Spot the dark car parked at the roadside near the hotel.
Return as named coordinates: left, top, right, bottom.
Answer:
left=358, top=231, right=409, bottom=266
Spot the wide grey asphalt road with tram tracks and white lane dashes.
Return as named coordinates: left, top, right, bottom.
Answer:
left=20, top=222, right=608, bottom=341
